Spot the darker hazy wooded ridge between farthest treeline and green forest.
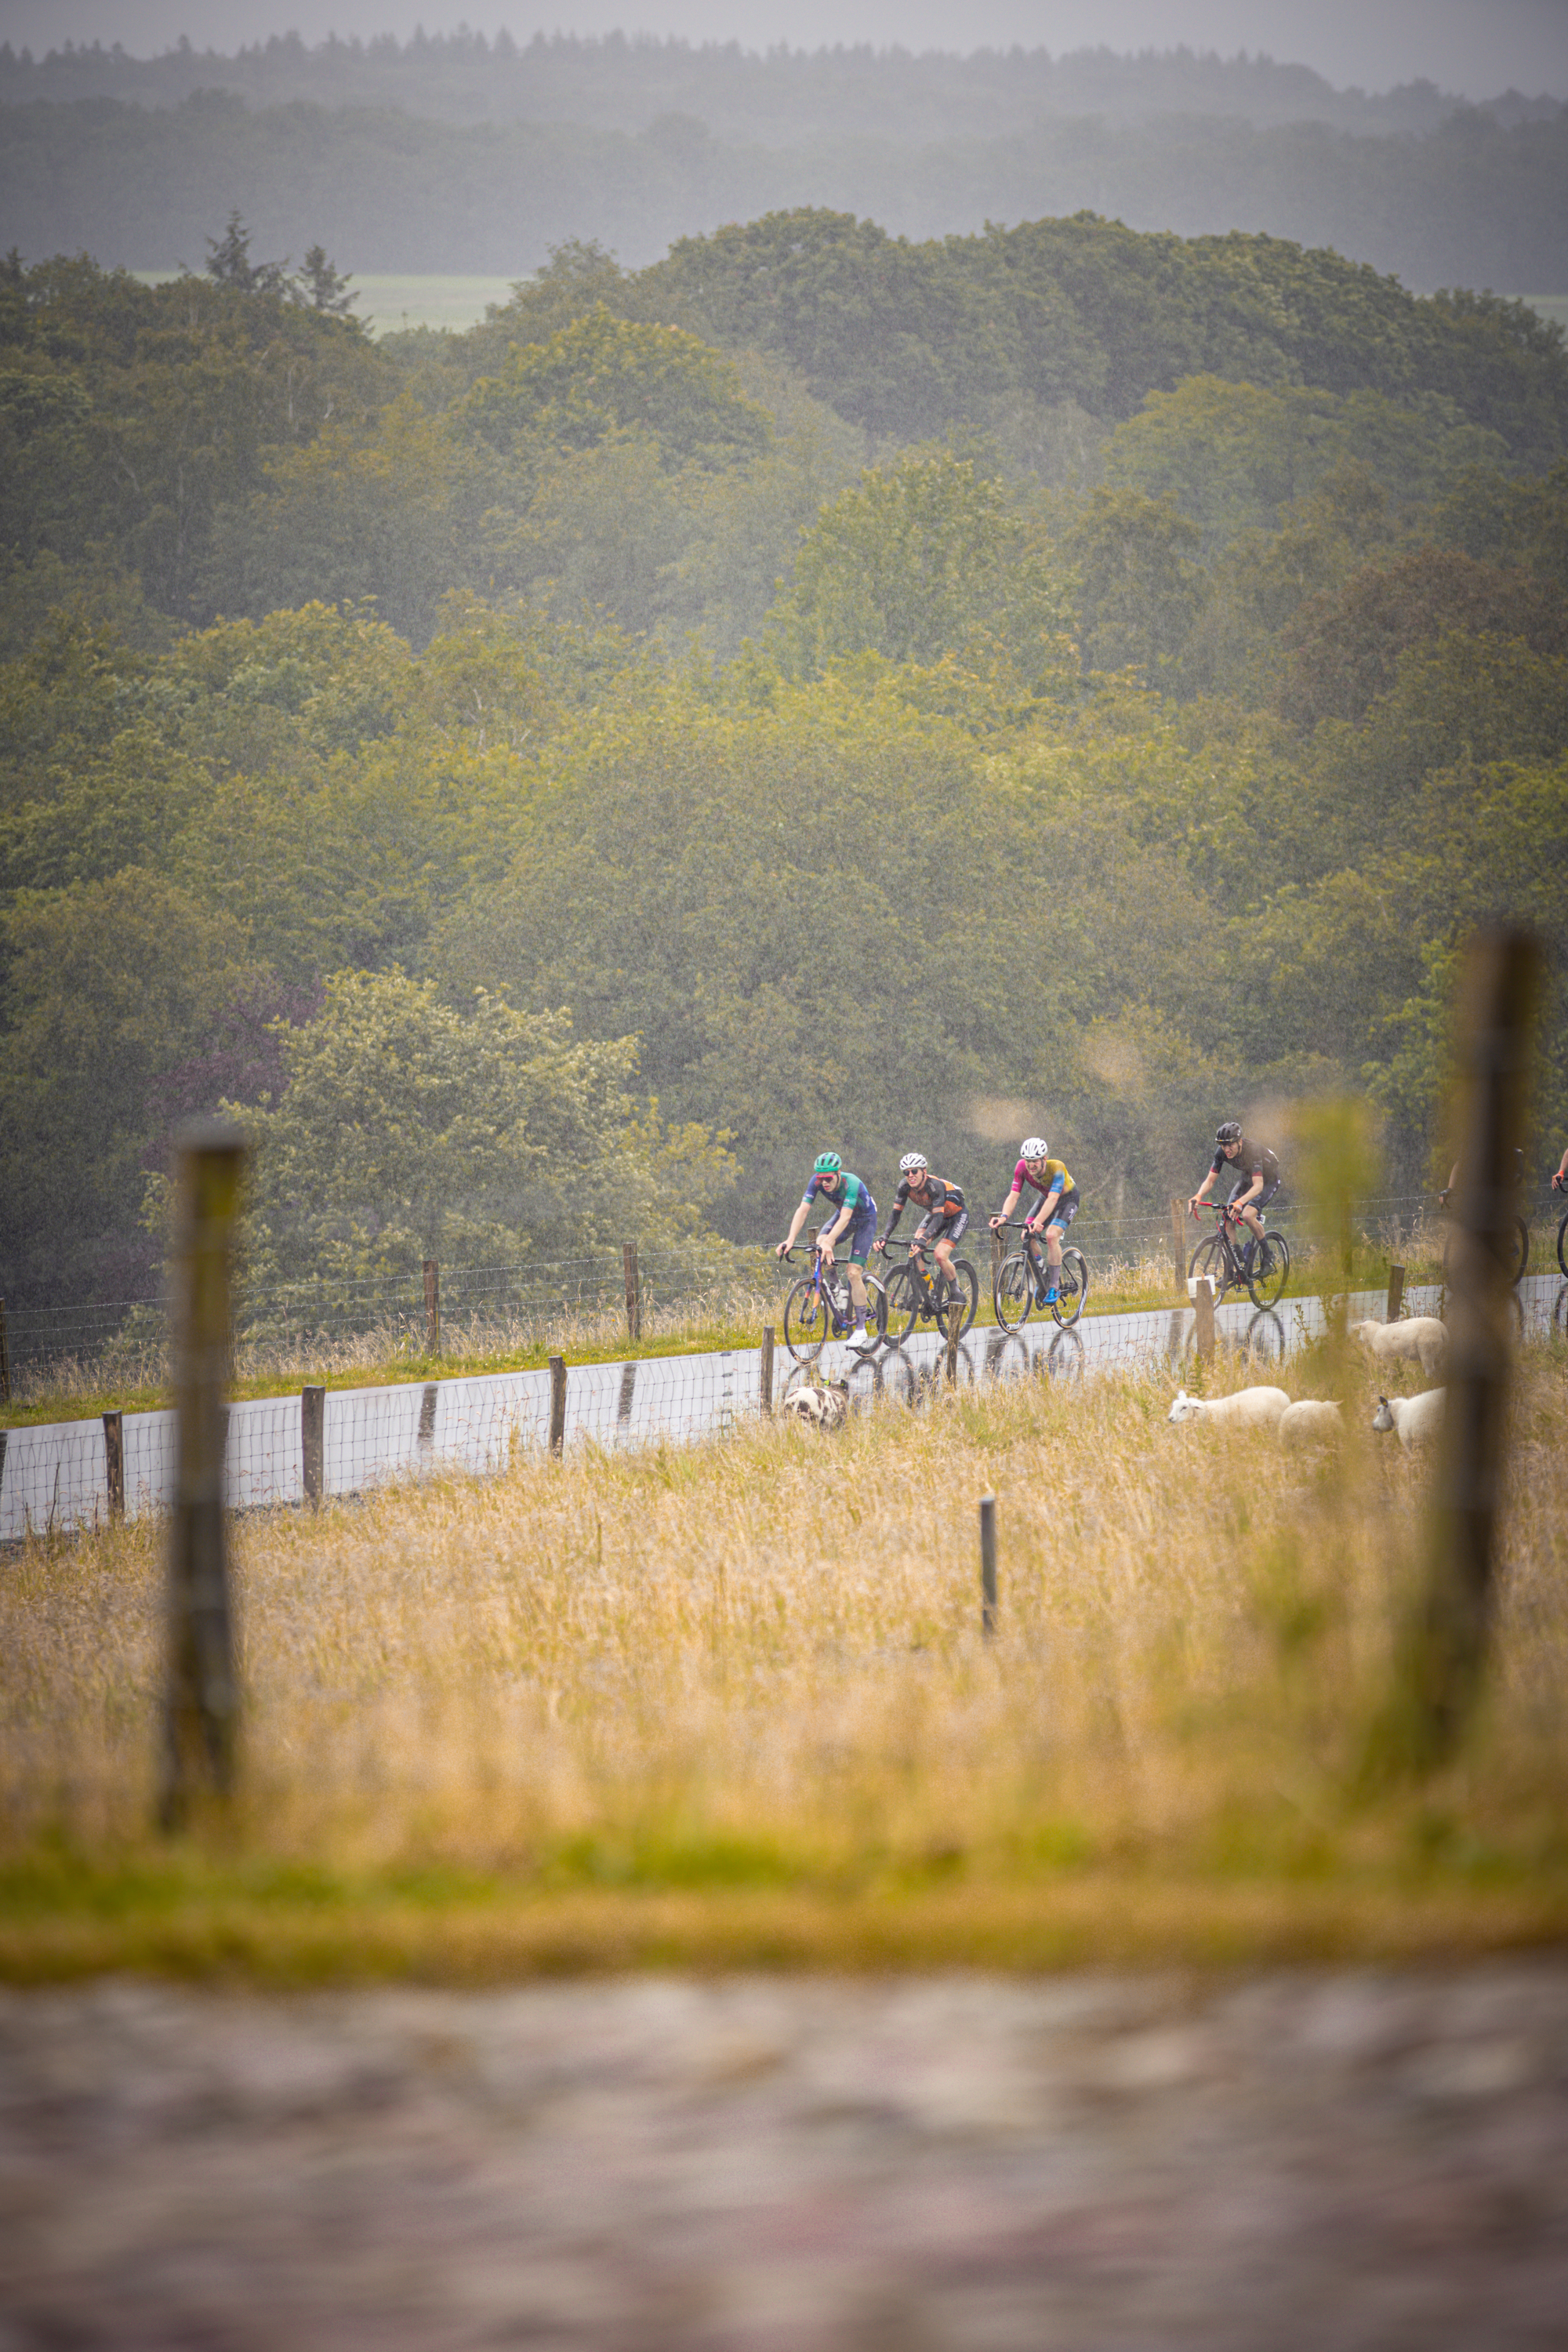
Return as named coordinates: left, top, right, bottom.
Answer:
left=0, top=85, right=1568, bottom=294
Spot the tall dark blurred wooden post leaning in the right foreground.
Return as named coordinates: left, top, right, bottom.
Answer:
left=1408, top=931, right=1540, bottom=1766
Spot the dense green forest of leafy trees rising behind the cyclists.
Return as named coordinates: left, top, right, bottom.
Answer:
left=0, top=209, right=1568, bottom=1301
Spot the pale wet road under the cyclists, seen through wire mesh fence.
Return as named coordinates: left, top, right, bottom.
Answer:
left=0, top=1275, right=1568, bottom=1543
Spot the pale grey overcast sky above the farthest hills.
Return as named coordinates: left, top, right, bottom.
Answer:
left=0, top=0, right=1568, bottom=96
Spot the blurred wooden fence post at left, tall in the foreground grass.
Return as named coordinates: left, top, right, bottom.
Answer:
left=158, top=1122, right=245, bottom=1830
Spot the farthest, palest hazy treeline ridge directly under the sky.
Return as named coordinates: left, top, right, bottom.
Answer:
left=0, top=31, right=1556, bottom=146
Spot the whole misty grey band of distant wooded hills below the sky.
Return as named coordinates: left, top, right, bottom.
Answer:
left=0, top=35, right=1568, bottom=294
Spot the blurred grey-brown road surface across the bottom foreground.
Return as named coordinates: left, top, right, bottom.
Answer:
left=0, top=1957, right=1568, bottom=2352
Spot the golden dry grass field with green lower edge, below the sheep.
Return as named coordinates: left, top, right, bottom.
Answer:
left=0, top=1350, right=1568, bottom=1980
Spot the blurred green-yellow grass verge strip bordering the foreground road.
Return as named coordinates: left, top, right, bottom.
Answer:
left=0, top=1844, right=1568, bottom=1985
